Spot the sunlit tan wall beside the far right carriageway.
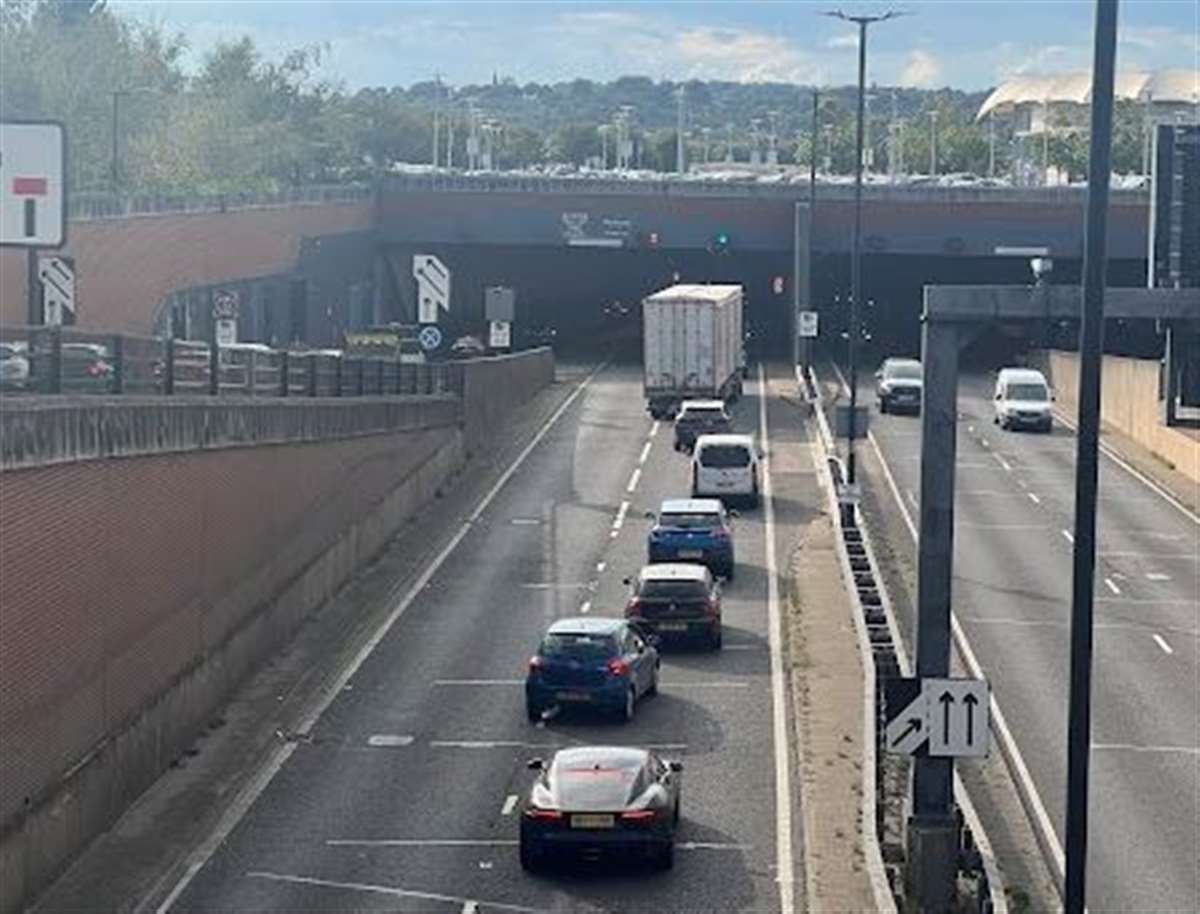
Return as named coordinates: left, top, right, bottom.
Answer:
left=1040, top=351, right=1200, bottom=483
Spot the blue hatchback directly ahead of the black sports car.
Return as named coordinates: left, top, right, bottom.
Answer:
left=526, top=618, right=659, bottom=721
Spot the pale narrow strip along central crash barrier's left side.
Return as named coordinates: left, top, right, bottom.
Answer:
left=797, top=368, right=896, bottom=914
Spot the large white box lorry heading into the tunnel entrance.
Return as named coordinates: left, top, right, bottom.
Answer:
left=642, top=285, right=746, bottom=419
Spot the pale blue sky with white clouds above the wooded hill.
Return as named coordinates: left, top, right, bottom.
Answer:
left=112, top=0, right=1200, bottom=90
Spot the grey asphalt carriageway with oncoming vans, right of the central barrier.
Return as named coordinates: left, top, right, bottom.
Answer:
left=859, top=364, right=1200, bottom=912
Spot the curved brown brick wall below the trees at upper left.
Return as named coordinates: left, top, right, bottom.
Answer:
left=0, top=200, right=374, bottom=333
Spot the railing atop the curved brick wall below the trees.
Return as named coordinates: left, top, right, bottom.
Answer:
left=67, top=184, right=376, bottom=222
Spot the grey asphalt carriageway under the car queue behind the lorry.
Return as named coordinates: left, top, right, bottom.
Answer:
left=159, top=366, right=811, bottom=912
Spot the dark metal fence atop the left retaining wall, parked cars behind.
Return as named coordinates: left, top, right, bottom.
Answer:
left=0, top=326, right=462, bottom=398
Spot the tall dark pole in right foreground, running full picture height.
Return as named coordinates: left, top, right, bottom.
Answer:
left=1063, top=0, right=1117, bottom=914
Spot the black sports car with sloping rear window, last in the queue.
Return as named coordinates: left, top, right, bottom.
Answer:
left=520, top=746, right=683, bottom=871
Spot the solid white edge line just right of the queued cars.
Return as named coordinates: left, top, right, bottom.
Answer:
left=758, top=362, right=796, bottom=914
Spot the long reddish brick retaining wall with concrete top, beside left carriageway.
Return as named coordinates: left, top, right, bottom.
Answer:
left=0, top=351, right=553, bottom=912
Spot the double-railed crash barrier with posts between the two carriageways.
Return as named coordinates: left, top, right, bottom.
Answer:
left=797, top=369, right=1008, bottom=914
